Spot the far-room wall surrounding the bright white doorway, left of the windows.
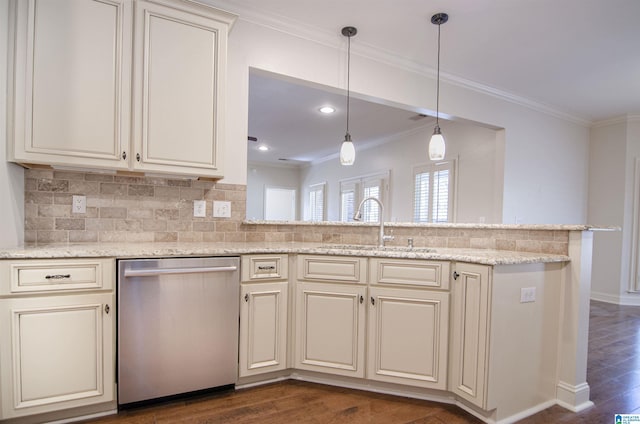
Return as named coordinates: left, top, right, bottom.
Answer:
left=247, top=164, right=300, bottom=220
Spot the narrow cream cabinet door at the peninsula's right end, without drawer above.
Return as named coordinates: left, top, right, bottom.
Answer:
left=449, top=263, right=491, bottom=409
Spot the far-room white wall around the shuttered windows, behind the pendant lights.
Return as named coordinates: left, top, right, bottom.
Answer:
left=300, top=121, right=502, bottom=223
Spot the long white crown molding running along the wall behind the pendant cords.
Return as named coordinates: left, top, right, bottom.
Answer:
left=208, top=0, right=594, bottom=127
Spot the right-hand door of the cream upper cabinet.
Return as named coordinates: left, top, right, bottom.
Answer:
left=133, top=0, right=228, bottom=177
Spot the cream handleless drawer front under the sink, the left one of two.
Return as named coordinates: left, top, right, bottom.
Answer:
left=298, top=255, right=367, bottom=283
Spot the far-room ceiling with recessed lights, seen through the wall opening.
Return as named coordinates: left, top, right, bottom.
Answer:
left=247, top=71, right=435, bottom=166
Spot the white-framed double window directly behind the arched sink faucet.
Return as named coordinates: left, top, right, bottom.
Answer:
left=340, top=172, right=389, bottom=222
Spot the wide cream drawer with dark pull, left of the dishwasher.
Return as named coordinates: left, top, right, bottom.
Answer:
left=0, top=259, right=115, bottom=295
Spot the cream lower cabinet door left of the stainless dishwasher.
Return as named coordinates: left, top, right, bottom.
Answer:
left=0, top=293, right=115, bottom=419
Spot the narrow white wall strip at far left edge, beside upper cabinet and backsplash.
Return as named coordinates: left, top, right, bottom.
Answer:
left=0, top=1, right=24, bottom=247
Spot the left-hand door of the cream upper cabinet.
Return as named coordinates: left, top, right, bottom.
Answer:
left=9, top=0, right=132, bottom=168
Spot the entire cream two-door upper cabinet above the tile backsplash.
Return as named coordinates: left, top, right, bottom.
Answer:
left=8, top=0, right=235, bottom=178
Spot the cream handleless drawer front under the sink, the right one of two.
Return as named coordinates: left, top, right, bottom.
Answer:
left=370, top=259, right=449, bottom=289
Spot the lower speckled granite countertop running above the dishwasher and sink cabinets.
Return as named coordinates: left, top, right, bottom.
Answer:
left=0, top=242, right=570, bottom=265
